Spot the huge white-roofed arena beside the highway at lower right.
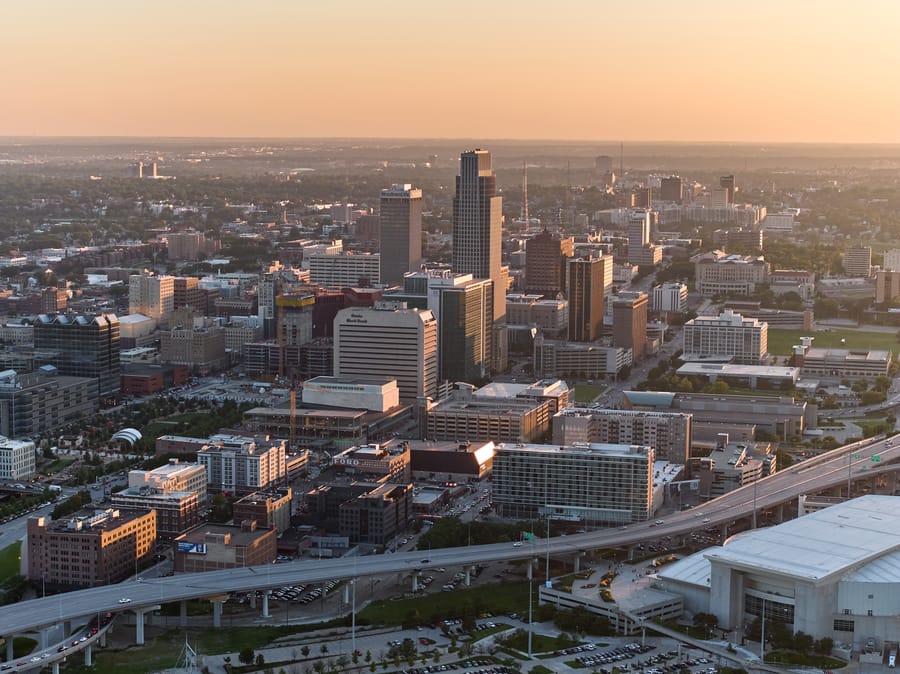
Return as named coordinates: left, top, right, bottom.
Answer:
left=659, top=495, right=900, bottom=644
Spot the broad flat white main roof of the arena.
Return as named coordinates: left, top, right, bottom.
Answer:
left=706, top=495, right=900, bottom=582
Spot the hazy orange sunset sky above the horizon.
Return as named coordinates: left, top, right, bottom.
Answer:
left=0, top=0, right=900, bottom=143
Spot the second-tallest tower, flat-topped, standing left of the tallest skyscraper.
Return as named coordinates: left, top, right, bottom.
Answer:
left=380, top=184, right=422, bottom=286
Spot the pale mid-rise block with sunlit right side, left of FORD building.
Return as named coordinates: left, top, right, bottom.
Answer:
left=197, top=435, right=287, bottom=494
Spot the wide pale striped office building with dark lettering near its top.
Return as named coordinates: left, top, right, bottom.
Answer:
left=334, top=301, right=438, bottom=403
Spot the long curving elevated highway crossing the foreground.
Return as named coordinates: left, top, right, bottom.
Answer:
left=0, top=430, right=900, bottom=636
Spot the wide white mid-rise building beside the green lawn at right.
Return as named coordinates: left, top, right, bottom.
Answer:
left=682, top=309, right=769, bottom=365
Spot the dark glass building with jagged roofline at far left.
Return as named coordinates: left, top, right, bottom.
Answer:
left=34, top=314, right=121, bottom=398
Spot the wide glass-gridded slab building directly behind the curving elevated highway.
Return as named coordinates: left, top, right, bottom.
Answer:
left=492, top=443, right=655, bottom=524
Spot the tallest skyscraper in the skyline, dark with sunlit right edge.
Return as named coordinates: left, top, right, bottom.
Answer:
left=450, top=150, right=506, bottom=323
